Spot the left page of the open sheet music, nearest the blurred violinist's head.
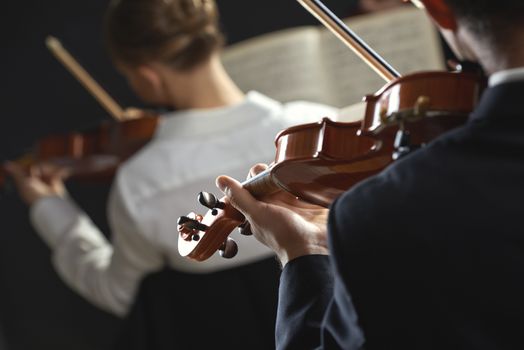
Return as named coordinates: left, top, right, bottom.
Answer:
left=222, top=27, right=328, bottom=102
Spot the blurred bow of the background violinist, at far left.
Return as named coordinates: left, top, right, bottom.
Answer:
left=45, top=36, right=125, bottom=121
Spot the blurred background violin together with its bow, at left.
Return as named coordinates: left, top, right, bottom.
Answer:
left=0, top=36, right=159, bottom=187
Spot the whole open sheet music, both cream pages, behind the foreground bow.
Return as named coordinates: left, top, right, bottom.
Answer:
left=222, top=7, right=444, bottom=107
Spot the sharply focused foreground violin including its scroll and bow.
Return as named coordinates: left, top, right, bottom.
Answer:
left=178, top=0, right=485, bottom=261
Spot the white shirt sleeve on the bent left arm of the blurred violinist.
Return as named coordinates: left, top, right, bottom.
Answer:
left=30, top=193, right=163, bottom=316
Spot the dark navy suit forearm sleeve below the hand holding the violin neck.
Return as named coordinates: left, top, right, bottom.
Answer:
left=276, top=255, right=364, bottom=350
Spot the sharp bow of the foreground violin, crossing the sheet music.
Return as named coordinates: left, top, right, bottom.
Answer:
left=298, top=0, right=400, bottom=82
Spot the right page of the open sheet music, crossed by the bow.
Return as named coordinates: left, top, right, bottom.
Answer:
left=319, top=7, right=444, bottom=106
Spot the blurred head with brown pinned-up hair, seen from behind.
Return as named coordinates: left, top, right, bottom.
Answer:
left=105, top=0, right=223, bottom=71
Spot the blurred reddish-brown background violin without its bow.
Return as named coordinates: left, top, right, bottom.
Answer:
left=0, top=116, right=159, bottom=186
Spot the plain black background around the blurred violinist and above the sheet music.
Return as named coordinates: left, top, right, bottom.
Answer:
left=0, top=0, right=355, bottom=350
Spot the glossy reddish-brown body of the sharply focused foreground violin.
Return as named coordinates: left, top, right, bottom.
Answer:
left=272, top=72, right=484, bottom=207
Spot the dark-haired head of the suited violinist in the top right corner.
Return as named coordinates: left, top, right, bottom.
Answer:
left=444, top=0, right=524, bottom=44
